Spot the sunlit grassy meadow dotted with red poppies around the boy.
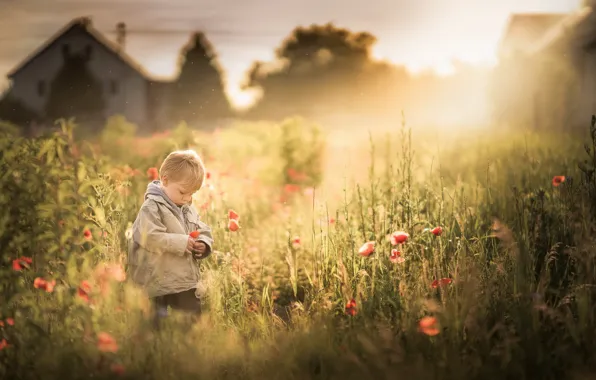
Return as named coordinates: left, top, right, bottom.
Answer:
left=0, top=118, right=596, bottom=380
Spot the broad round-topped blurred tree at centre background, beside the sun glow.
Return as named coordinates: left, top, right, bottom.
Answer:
left=244, top=23, right=407, bottom=118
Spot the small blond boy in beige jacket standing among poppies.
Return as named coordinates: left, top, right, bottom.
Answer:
left=128, top=150, right=213, bottom=328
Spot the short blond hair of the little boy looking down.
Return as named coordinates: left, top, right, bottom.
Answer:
left=159, top=150, right=205, bottom=191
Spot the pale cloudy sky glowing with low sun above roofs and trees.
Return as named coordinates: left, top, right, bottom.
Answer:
left=0, top=0, right=581, bottom=105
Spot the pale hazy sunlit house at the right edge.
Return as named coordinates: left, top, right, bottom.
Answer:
left=499, top=6, right=596, bottom=129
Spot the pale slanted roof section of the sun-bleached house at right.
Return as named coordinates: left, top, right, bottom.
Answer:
left=499, top=13, right=567, bottom=53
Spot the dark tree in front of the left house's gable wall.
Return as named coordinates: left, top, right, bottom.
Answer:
left=45, top=45, right=105, bottom=121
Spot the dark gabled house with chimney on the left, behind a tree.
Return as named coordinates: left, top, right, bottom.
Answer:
left=7, top=17, right=170, bottom=129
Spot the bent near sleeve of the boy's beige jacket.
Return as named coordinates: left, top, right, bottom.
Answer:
left=133, top=201, right=188, bottom=256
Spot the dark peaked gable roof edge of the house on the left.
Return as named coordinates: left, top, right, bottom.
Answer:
left=6, top=17, right=151, bottom=79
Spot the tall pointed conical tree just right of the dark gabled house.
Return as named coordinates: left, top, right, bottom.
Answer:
left=170, top=32, right=231, bottom=123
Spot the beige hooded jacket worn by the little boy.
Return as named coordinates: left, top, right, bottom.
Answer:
left=127, top=181, right=213, bottom=297
